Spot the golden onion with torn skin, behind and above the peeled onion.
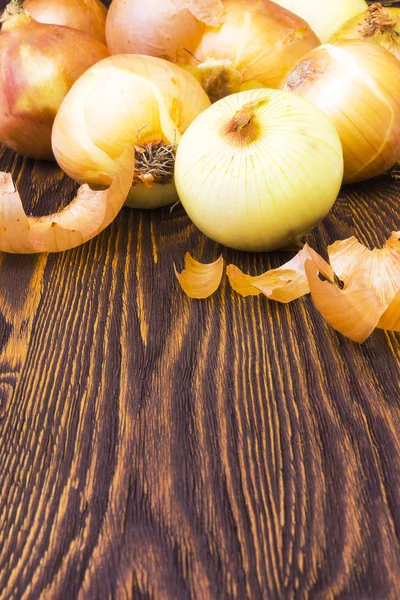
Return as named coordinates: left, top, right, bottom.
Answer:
left=180, top=0, right=320, bottom=101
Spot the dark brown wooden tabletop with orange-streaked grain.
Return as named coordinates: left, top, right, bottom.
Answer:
left=0, top=1, right=400, bottom=600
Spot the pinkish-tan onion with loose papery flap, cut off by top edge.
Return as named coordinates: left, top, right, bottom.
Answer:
left=106, top=0, right=223, bottom=62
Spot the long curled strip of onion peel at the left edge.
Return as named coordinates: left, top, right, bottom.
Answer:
left=0, top=149, right=134, bottom=254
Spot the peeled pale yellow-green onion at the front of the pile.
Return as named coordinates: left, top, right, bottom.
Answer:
left=175, top=89, right=343, bottom=251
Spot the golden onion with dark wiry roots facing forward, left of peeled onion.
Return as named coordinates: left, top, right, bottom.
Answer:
left=52, top=54, right=210, bottom=208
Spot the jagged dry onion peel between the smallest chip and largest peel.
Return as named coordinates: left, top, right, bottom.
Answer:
left=226, top=244, right=334, bottom=304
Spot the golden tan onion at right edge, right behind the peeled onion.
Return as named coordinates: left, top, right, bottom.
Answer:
left=284, top=40, right=400, bottom=183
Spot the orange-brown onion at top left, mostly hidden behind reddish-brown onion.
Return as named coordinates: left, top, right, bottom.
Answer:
left=22, top=0, right=107, bottom=42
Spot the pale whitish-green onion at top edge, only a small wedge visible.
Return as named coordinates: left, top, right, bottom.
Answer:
left=275, top=0, right=368, bottom=42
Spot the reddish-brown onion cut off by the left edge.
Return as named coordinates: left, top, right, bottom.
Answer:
left=0, top=2, right=108, bottom=159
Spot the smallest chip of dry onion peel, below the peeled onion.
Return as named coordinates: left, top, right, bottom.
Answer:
left=174, top=252, right=224, bottom=300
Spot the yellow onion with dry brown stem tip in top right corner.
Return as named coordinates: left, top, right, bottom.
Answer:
left=330, top=2, right=400, bottom=59
